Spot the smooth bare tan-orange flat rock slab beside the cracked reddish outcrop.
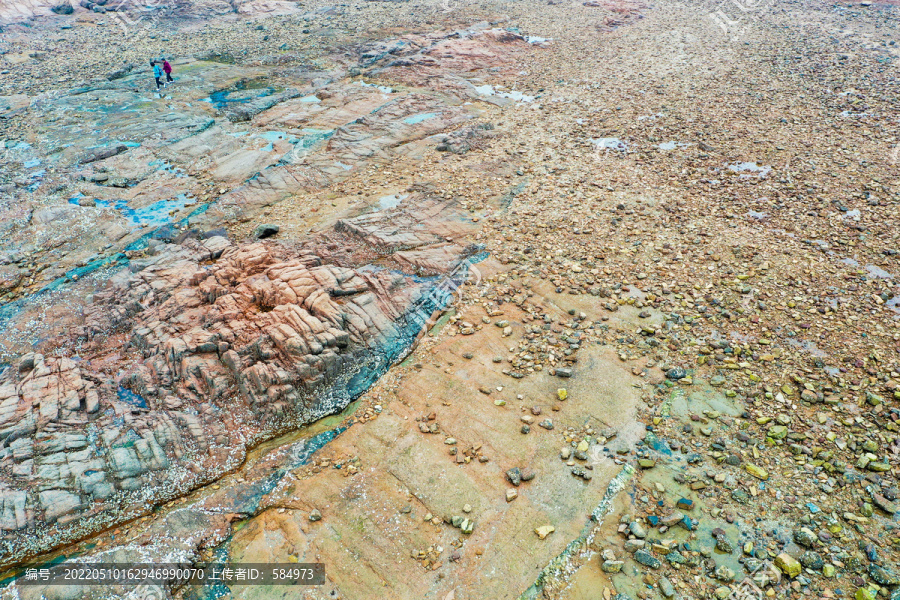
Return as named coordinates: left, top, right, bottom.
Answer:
left=211, top=338, right=639, bottom=598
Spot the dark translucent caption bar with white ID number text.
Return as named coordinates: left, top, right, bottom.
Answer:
left=16, top=563, right=325, bottom=586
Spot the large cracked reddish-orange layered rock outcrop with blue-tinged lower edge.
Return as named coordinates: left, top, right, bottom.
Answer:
left=0, top=199, right=478, bottom=563
